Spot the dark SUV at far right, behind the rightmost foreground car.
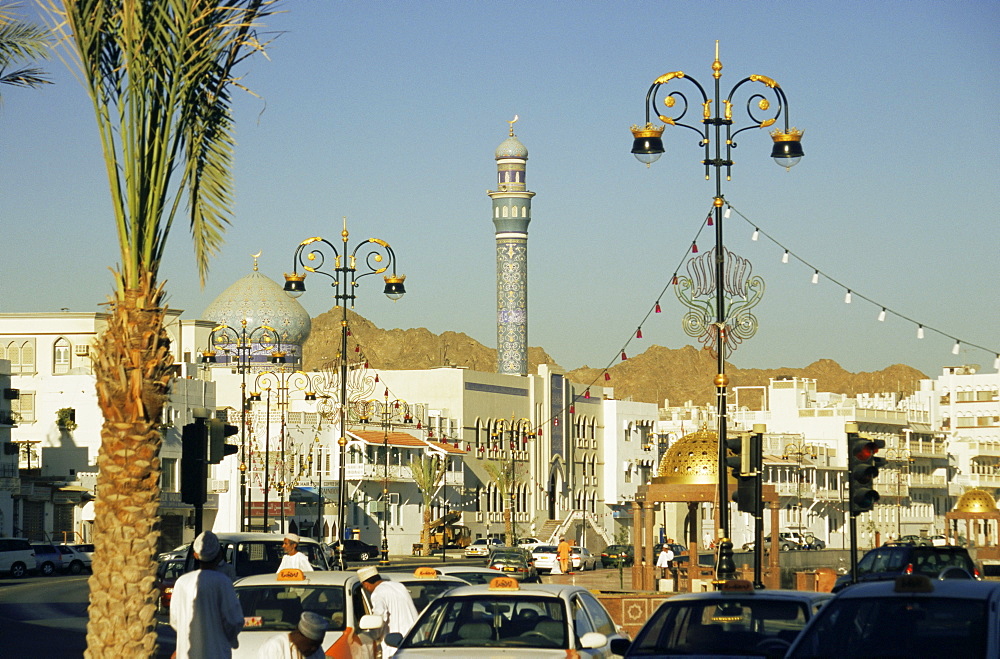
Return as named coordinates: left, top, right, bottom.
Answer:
left=833, top=544, right=981, bottom=592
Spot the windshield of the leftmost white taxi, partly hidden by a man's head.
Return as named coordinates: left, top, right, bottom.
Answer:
left=236, top=585, right=346, bottom=632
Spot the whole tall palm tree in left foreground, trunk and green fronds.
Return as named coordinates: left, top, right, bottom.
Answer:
left=45, top=0, right=273, bottom=657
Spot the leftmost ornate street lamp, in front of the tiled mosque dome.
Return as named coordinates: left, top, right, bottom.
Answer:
left=201, top=318, right=286, bottom=531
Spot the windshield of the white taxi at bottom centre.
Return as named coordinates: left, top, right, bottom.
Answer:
left=400, top=593, right=569, bottom=649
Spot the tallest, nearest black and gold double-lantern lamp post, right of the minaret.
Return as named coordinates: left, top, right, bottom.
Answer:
left=632, top=41, right=803, bottom=580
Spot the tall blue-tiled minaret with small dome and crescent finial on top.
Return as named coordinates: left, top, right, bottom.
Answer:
left=486, top=115, right=535, bottom=375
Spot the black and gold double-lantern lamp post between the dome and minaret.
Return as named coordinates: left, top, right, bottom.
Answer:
left=285, top=218, right=406, bottom=570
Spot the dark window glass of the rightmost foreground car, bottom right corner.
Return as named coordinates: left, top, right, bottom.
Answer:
left=790, top=597, right=988, bottom=659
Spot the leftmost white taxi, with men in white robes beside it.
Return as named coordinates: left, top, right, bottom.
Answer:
left=233, top=569, right=382, bottom=659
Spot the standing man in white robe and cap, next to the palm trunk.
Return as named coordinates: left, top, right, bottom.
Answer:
left=170, top=531, right=243, bottom=659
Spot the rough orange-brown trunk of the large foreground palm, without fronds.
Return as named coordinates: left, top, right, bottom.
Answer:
left=85, top=273, right=173, bottom=659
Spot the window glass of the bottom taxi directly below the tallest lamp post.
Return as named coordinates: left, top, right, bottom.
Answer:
left=629, top=597, right=809, bottom=657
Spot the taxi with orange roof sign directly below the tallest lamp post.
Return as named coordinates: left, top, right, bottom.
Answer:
left=611, top=579, right=832, bottom=658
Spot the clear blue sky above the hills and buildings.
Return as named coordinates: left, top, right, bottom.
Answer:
left=0, top=0, right=1000, bottom=384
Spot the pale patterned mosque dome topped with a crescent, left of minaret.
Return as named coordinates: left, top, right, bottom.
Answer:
left=202, top=266, right=312, bottom=346
